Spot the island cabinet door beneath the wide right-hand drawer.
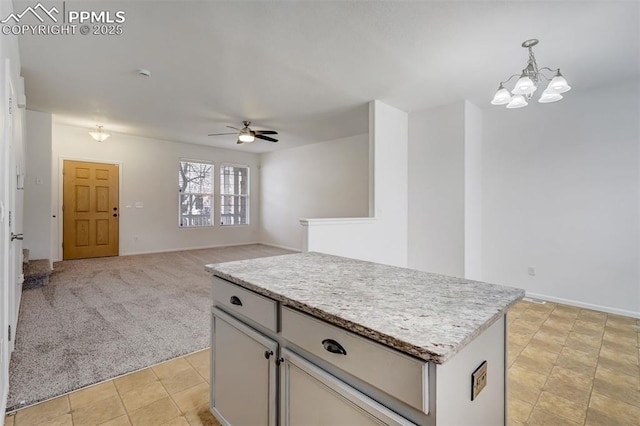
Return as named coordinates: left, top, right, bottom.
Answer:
left=280, top=349, right=413, bottom=426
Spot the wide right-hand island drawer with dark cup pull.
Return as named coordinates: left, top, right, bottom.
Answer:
left=282, top=307, right=429, bottom=414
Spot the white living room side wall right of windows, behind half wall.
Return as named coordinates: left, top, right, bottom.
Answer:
left=260, top=134, right=369, bottom=250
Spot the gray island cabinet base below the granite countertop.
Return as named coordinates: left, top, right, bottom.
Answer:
left=210, top=277, right=506, bottom=426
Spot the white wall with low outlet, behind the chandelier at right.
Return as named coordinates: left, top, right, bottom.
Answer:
left=483, top=80, right=640, bottom=316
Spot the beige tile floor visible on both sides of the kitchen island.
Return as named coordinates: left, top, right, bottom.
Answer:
left=5, top=301, right=640, bottom=426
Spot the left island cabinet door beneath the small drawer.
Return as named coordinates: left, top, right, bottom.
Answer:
left=211, top=308, right=278, bottom=426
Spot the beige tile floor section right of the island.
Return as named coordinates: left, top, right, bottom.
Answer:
left=507, top=301, right=640, bottom=426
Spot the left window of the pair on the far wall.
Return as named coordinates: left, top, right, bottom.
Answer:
left=178, top=160, right=213, bottom=228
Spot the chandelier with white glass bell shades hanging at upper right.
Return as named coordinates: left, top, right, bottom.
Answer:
left=491, top=38, right=571, bottom=109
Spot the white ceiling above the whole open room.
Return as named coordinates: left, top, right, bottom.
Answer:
left=14, top=0, right=640, bottom=152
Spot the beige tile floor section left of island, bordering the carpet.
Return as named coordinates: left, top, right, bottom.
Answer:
left=5, top=349, right=219, bottom=426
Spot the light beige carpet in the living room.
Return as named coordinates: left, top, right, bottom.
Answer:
left=7, top=244, right=291, bottom=411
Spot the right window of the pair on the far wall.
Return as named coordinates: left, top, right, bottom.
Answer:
left=220, top=164, right=249, bottom=225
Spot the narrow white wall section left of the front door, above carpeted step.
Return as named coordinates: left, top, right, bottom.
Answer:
left=24, top=110, right=55, bottom=259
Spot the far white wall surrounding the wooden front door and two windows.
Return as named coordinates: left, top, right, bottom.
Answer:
left=50, top=124, right=260, bottom=260
